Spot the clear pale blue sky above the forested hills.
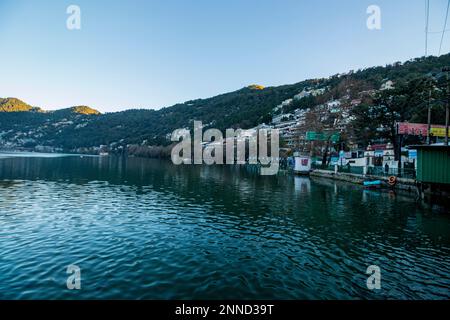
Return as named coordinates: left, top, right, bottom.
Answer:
left=0, top=0, right=450, bottom=111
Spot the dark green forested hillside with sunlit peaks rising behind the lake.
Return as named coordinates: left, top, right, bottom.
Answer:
left=0, top=54, right=450, bottom=151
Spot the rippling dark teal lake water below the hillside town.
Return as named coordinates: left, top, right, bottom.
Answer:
left=0, top=154, right=450, bottom=299
